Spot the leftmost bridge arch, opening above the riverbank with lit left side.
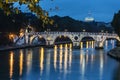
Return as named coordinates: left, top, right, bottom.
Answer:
left=30, top=35, right=46, bottom=45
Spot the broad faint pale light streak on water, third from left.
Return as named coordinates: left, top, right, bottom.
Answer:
left=26, top=50, right=32, bottom=74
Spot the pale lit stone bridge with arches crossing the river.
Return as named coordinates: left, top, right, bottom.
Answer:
left=16, top=32, right=120, bottom=48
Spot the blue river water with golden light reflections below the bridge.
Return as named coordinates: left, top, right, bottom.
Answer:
left=0, top=40, right=119, bottom=80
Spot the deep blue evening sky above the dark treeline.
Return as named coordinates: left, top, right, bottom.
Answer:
left=41, top=0, right=120, bottom=22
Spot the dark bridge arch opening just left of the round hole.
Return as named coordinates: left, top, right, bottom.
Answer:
left=53, top=35, right=73, bottom=44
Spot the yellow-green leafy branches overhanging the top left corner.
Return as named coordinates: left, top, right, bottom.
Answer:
left=0, top=0, right=53, bottom=24
